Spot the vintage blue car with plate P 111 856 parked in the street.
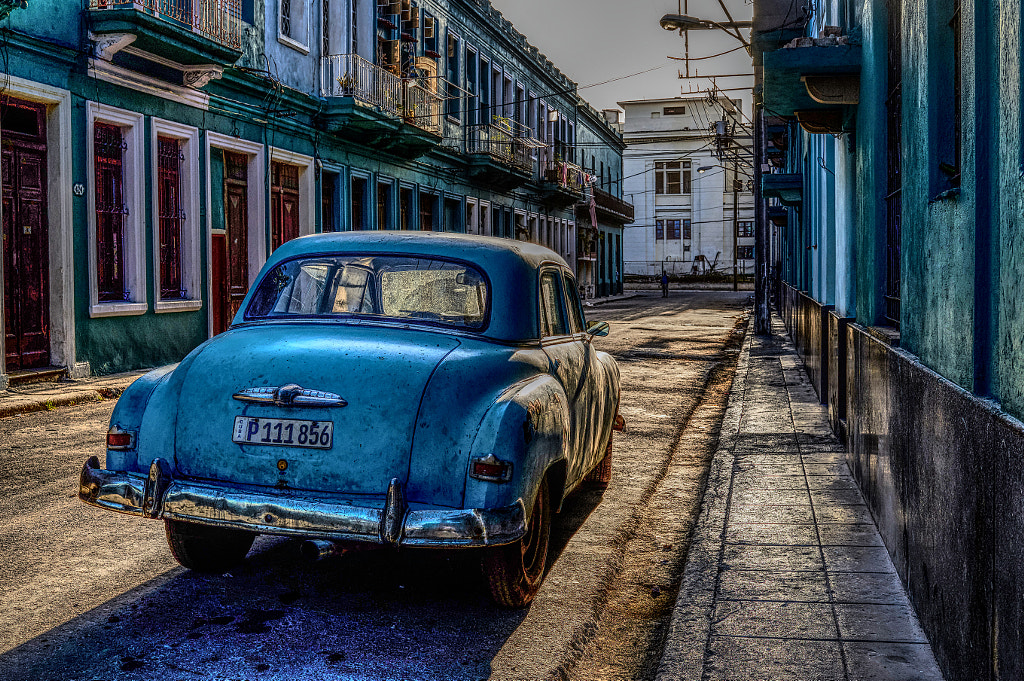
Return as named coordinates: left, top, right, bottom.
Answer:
left=79, top=231, right=622, bottom=607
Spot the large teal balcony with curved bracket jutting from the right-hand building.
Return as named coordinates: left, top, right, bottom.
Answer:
left=764, top=35, right=861, bottom=134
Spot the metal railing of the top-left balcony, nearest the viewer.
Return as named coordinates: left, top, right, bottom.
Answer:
left=89, top=0, right=242, bottom=49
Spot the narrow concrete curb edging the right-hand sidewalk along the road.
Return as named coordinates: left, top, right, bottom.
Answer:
left=655, top=321, right=754, bottom=681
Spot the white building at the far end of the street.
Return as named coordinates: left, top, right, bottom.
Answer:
left=618, top=96, right=754, bottom=275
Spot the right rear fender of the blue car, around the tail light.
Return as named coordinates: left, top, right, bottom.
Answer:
left=465, top=374, right=569, bottom=508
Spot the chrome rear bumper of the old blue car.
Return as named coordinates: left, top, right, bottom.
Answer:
left=78, top=457, right=526, bottom=547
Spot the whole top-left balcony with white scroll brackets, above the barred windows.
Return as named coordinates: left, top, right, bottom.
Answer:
left=89, top=0, right=244, bottom=67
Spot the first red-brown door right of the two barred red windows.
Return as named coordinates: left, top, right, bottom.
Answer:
left=210, top=152, right=249, bottom=334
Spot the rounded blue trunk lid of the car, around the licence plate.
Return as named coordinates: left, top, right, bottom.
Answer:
left=175, top=323, right=459, bottom=495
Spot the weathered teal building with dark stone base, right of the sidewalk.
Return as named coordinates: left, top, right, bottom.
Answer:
left=752, top=0, right=1024, bottom=680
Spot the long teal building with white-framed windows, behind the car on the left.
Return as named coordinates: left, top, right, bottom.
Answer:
left=0, top=0, right=623, bottom=385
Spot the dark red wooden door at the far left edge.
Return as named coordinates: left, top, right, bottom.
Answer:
left=0, top=99, right=50, bottom=372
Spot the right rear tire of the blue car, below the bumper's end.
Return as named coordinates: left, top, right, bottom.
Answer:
left=482, top=478, right=551, bottom=607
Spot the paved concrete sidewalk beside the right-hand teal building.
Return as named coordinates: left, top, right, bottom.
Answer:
left=657, top=317, right=942, bottom=681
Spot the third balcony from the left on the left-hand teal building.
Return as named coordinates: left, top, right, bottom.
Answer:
left=466, top=124, right=534, bottom=188
